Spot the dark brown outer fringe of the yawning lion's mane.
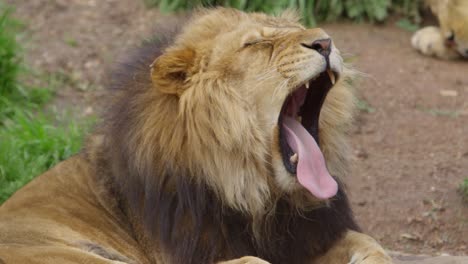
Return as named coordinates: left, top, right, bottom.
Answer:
left=98, top=19, right=358, bottom=264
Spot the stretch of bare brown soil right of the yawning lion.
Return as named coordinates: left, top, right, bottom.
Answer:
left=325, top=24, right=468, bottom=254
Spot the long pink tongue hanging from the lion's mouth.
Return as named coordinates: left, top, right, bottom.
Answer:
left=283, top=115, right=338, bottom=199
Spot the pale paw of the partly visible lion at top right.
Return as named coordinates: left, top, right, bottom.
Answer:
left=411, top=27, right=458, bottom=59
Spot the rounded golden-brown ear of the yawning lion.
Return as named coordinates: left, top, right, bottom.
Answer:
left=151, top=49, right=195, bottom=95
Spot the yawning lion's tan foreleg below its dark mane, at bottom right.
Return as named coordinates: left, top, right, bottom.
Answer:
left=313, top=231, right=393, bottom=264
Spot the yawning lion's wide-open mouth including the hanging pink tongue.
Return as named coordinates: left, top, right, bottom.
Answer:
left=278, top=69, right=338, bottom=199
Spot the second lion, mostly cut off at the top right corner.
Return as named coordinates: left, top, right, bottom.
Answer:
left=411, top=0, right=468, bottom=59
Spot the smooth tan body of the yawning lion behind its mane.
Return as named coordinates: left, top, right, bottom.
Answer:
left=0, top=154, right=149, bottom=264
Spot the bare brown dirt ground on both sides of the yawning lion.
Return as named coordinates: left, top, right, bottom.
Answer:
left=6, top=0, right=468, bottom=255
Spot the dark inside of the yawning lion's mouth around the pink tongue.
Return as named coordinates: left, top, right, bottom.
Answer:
left=278, top=68, right=339, bottom=174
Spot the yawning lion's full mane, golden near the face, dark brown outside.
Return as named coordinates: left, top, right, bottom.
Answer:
left=88, top=11, right=358, bottom=263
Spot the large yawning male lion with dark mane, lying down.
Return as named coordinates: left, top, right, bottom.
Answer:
left=0, top=8, right=392, bottom=264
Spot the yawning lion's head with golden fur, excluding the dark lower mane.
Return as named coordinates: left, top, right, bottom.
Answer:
left=106, top=9, right=353, bottom=214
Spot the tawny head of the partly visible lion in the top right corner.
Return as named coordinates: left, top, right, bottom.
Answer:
left=429, top=0, right=468, bottom=58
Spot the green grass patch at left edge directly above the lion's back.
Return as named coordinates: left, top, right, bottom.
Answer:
left=0, top=108, right=93, bottom=203
